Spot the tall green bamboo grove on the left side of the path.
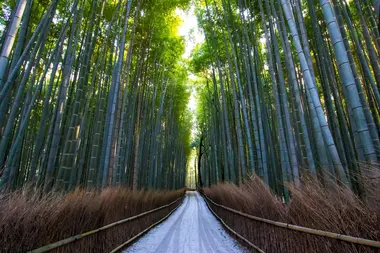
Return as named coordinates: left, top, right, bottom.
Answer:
left=0, top=0, right=191, bottom=192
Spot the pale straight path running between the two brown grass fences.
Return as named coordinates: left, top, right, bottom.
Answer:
left=124, top=192, right=245, bottom=253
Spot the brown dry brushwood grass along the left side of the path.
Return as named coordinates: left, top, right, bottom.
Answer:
left=0, top=188, right=184, bottom=253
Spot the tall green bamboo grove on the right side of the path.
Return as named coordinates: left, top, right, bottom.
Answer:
left=191, top=0, right=380, bottom=199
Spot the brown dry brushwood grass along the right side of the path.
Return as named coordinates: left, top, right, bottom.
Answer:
left=203, top=170, right=380, bottom=253
